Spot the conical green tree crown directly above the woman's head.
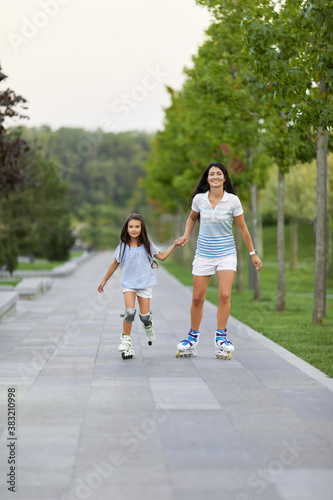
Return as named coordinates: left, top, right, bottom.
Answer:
left=147, top=2, right=271, bottom=211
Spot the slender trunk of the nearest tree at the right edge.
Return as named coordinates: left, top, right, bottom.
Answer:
left=312, top=128, right=327, bottom=323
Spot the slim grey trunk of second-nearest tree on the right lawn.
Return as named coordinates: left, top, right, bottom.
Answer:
left=276, top=168, right=286, bottom=312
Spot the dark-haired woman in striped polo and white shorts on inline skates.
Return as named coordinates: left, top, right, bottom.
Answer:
left=176, top=163, right=262, bottom=359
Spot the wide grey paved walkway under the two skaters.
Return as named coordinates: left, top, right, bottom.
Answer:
left=0, top=252, right=333, bottom=500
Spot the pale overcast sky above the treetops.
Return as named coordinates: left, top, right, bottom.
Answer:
left=0, top=0, right=210, bottom=133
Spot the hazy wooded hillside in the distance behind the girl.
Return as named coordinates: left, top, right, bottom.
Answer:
left=21, top=127, right=154, bottom=249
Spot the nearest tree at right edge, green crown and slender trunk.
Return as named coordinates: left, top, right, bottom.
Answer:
left=243, top=0, right=333, bottom=323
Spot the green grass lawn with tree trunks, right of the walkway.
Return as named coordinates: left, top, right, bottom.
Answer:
left=163, top=228, right=333, bottom=377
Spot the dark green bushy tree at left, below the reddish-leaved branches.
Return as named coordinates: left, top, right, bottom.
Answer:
left=0, top=137, right=74, bottom=270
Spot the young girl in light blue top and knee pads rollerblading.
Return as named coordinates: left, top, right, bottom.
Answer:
left=97, top=214, right=180, bottom=359
